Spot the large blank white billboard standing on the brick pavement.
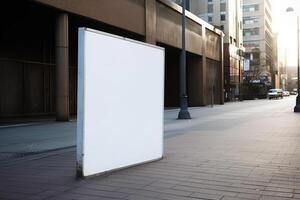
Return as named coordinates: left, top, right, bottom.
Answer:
left=77, top=28, right=164, bottom=176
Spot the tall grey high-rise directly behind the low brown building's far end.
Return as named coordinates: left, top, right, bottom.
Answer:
left=171, top=0, right=244, bottom=101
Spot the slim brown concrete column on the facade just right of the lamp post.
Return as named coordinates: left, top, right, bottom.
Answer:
left=200, top=25, right=208, bottom=105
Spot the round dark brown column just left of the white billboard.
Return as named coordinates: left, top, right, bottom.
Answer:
left=55, top=13, right=69, bottom=121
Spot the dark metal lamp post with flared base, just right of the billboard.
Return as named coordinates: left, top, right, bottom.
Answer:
left=178, top=0, right=191, bottom=119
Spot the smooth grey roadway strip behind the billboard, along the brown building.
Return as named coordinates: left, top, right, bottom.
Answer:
left=0, top=97, right=295, bottom=161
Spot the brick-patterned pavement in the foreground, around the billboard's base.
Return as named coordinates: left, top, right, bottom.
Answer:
left=0, top=98, right=300, bottom=200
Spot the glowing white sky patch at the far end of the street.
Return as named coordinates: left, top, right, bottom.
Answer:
left=270, top=0, right=300, bottom=66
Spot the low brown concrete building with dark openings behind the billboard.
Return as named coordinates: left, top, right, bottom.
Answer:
left=0, top=0, right=224, bottom=122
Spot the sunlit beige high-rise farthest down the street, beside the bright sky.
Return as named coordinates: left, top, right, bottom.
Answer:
left=243, top=0, right=275, bottom=87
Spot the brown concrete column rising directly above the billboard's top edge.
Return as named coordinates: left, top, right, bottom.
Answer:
left=145, top=0, right=156, bottom=44
